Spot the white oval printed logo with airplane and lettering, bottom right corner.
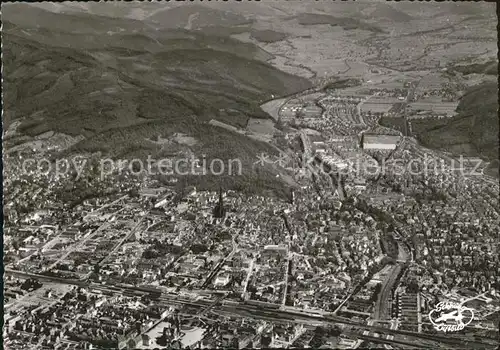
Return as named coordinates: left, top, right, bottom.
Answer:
left=429, top=301, right=474, bottom=333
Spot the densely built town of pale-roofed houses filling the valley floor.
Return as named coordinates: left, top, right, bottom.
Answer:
left=4, top=69, right=500, bottom=349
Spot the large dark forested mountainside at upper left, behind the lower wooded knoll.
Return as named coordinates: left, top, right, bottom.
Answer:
left=2, top=5, right=311, bottom=197
